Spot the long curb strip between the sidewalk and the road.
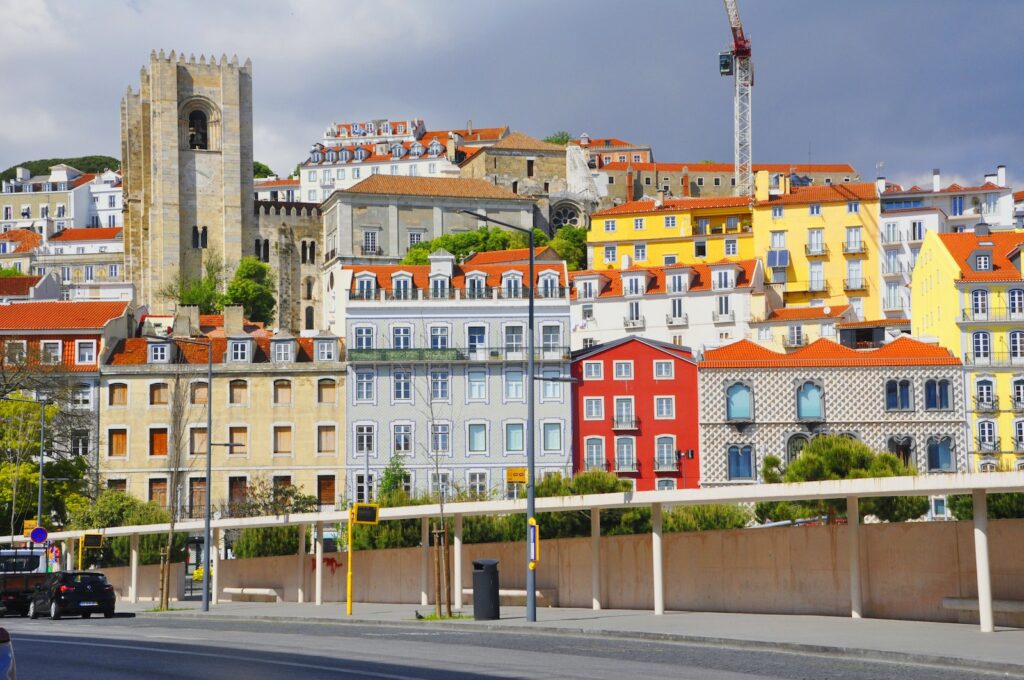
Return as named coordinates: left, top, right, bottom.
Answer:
left=135, top=611, right=1024, bottom=678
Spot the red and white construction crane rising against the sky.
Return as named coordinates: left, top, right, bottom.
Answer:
left=718, top=0, right=754, bottom=196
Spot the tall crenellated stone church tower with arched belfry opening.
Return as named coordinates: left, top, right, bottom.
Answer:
left=121, top=50, right=258, bottom=312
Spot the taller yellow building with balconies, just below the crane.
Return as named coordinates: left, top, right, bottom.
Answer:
left=753, top=172, right=885, bottom=320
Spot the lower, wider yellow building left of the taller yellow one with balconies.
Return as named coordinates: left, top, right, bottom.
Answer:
left=587, top=197, right=755, bottom=269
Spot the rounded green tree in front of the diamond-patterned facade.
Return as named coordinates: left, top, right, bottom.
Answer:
left=755, top=435, right=928, bottom=521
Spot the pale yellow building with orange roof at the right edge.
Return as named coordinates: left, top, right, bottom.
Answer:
left=910, top=227, right=1024, bottom=471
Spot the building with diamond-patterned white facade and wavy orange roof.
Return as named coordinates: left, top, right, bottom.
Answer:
left=698, top=338, right=969, bottom=485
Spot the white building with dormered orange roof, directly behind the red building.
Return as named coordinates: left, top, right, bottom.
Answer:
left=570, top=259, right=766, bottom=350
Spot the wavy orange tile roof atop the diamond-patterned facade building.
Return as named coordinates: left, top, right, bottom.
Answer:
left=699, top=336, right=961, bottom=369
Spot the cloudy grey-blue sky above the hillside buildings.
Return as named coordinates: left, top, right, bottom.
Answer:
left=0, top=0, right=1024, bottom=188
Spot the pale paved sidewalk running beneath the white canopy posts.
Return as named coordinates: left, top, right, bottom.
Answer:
left=118, top=602, right=1024, bottom=675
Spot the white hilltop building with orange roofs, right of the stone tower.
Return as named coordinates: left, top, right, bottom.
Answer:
left=297, top=119, right=508, bottom=203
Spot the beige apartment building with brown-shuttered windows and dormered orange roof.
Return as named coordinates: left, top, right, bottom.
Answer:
left=99, top=307, right=345, bottom=516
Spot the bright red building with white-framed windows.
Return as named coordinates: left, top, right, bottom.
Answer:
left=572, top=337, right=700, bottom=491
